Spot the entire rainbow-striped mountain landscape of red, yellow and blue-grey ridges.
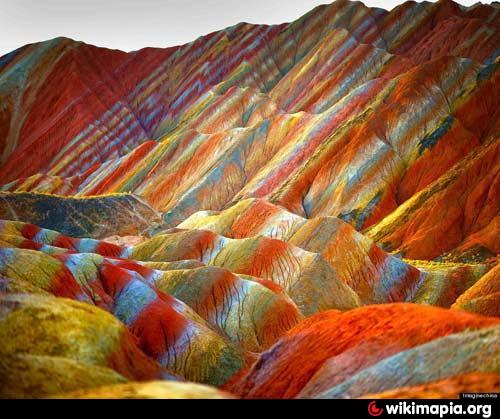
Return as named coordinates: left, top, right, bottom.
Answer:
left=0, top=0, right=500, bottom=398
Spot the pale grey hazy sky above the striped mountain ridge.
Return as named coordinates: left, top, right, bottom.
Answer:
left=0, top=0, right=492, bottom=56
